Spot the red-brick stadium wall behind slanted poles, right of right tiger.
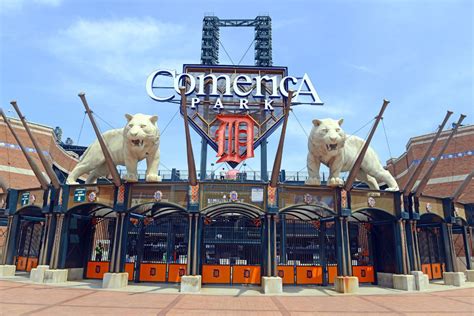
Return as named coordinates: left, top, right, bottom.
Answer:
left=387, top=125, right=474, bottom=203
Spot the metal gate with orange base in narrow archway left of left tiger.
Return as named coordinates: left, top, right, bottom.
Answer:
left=16, top=219, right=44, bottom=271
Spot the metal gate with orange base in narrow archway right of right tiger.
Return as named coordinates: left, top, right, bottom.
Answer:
left=417, top=226, right=446, bottom=280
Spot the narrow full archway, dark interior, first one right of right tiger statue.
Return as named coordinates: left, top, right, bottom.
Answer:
left=417, top=213, right=446, bottom=280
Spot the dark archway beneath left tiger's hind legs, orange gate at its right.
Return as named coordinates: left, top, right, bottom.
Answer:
left=64, top=203, right=117, bottom=279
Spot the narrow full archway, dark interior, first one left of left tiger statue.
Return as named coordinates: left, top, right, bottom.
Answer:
left=15, top=206, right=45, bottom=272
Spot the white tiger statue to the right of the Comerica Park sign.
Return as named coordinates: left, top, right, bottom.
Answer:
left=306, top=119, right=399, bottom=191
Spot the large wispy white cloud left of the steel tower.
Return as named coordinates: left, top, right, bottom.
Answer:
left=48, top=18, right=199, bottom=82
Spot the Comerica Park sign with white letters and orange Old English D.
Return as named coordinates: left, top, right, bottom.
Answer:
left=146, top=65, right=323, bottom=166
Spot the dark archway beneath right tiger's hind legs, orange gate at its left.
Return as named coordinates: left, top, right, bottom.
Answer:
left=349, top=208, right=397, bottom=283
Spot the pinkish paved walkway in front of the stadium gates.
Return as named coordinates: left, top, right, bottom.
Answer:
left=0, top=280, right=474, bottom=316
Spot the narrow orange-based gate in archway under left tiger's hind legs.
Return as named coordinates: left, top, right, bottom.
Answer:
left=86, top=216, right=116, bottom=279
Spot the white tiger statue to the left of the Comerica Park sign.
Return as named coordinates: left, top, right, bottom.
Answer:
left=66, top=113, right=161, bottom=184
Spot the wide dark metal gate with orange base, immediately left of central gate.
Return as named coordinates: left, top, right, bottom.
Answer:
left=130, top=214, right=189, bottom=283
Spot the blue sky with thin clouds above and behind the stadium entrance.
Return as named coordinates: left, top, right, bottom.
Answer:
left=0, top=0, right=474, bottom=177
